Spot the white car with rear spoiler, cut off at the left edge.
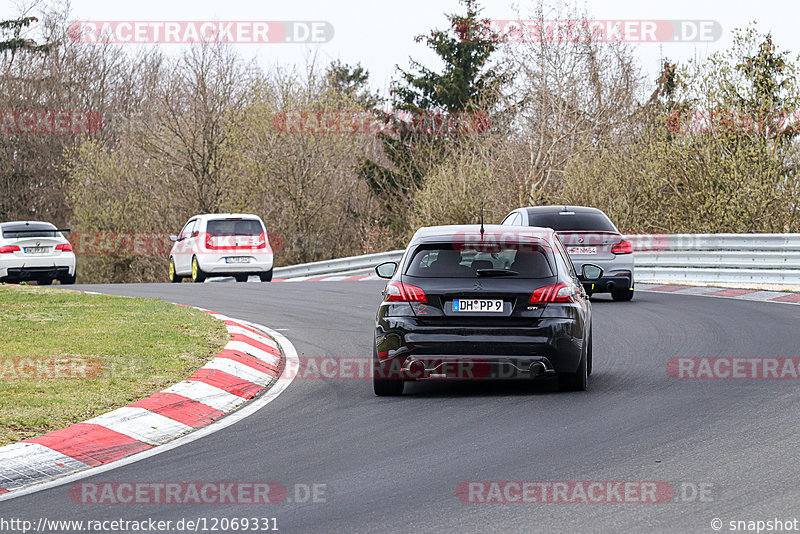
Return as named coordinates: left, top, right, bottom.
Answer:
left=0, top=221, right=75, bottom=286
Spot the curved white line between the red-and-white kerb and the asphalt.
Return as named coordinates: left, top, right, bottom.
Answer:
left=0, top=319, right=300, bottom=501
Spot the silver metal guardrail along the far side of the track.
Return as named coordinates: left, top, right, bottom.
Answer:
left=274, top=234, right=800, bottom=284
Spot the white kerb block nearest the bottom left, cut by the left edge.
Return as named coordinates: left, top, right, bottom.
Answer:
left=0, top=443, right=86, bottom=490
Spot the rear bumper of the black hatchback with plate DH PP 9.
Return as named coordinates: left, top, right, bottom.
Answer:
left=375, top=317, right=585, bottom=380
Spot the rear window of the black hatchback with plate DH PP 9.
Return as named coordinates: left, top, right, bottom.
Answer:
left=405, top=240, right=555, bottom=278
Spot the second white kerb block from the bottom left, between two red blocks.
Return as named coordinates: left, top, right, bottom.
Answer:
left=85, top=406, right=194, bottom=445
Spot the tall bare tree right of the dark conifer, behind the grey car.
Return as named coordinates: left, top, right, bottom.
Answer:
left=503, top=1, right=643, bottom=204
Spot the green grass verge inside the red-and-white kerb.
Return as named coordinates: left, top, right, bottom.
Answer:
left=0, top=285, right=228, bottom=446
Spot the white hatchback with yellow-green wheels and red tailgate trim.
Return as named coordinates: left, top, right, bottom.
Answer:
left=169, top=213, right=273, bottom=282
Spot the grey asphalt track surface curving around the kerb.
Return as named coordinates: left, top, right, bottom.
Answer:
left=0, top=281, right=800, bottom=533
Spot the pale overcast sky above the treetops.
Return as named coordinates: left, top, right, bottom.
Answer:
left=6, top=0, right=800, bottom=95
